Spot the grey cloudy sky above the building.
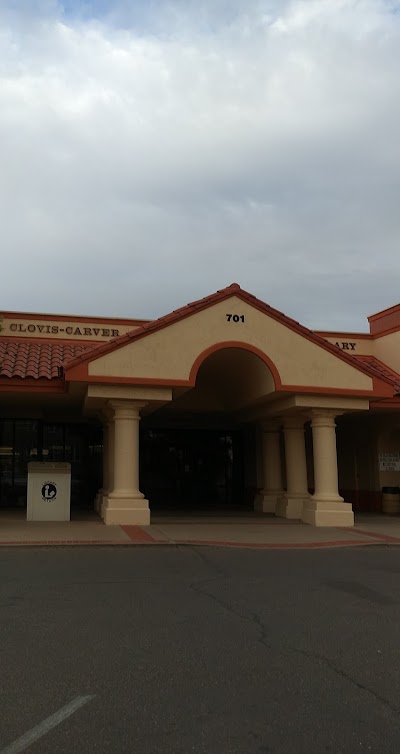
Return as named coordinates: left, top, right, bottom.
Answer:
left=0, top=0, right=400, bottom=330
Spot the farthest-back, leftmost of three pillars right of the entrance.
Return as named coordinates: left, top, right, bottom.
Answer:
left=254, top=422, right=283, bottom=513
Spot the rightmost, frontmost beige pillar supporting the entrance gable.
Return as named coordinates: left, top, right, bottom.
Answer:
left=302, top=411, right=354, bottom=526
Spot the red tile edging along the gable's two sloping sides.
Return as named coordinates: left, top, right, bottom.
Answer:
left=64, top=283, right=393, bottom=385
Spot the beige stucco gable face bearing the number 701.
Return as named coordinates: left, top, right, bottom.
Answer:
left=89, top=296, right=372, bottom=390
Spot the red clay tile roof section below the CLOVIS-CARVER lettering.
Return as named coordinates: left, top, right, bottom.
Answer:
left=0, top=338, right=93, bottom=380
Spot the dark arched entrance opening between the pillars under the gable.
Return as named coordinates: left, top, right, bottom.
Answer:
left=140, top=343, right=275, bottom=512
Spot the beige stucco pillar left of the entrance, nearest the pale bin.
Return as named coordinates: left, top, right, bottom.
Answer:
left=104, top=400, right=150, bottom=524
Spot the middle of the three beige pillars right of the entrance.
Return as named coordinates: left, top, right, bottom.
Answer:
left=275, top=417, right=309, bottom=519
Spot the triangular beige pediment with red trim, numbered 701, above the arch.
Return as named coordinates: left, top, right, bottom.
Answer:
left=65, top=284, right=393, bottom=395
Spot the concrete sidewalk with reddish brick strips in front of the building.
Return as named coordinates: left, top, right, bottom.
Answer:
left=0, top=513, right=400, bottom=549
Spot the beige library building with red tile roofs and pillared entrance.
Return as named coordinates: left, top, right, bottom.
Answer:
left=0, top=283, right=400, bottom=527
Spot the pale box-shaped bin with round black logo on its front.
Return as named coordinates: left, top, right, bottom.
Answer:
left=26, top=461, right=71, bottom=521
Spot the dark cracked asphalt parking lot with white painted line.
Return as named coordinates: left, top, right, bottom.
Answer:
left=0, top=545, right=400, bottom=754
